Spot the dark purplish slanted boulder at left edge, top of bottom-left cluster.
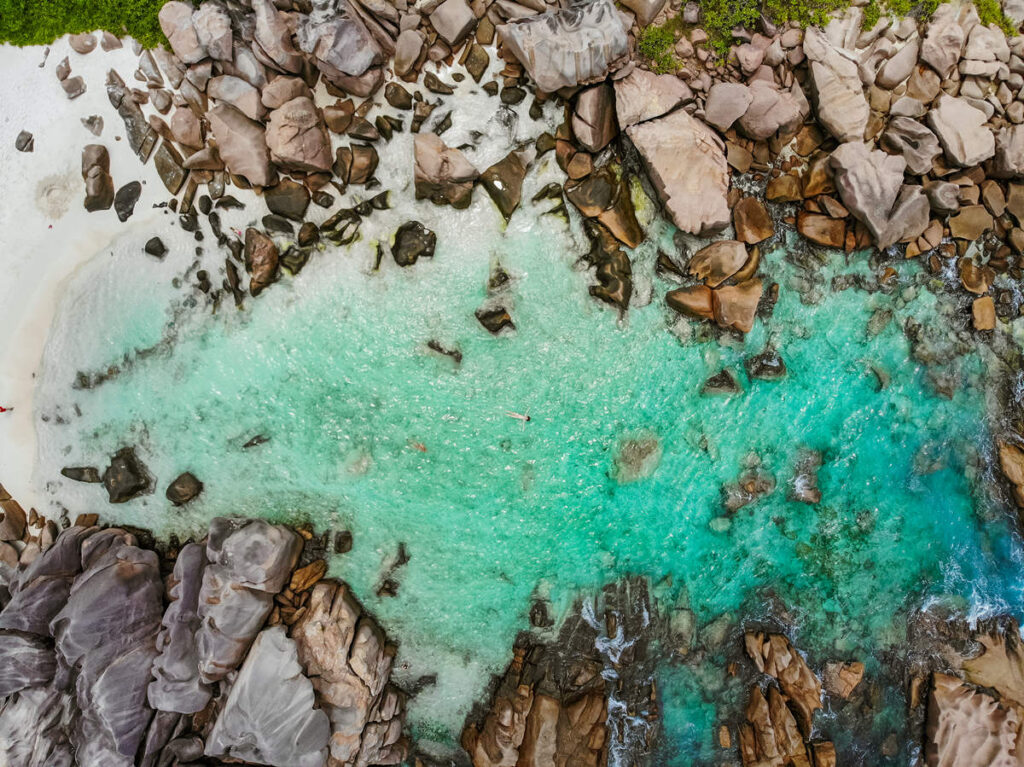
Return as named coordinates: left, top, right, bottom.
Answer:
left=0, top=526, right=96, bottom=637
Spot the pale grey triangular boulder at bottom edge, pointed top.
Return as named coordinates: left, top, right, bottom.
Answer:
left=206, top=626, right=331, bottom=767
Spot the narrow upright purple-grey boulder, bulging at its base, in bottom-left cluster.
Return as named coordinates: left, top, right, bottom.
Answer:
left=147, top=544, right=211, bottom=714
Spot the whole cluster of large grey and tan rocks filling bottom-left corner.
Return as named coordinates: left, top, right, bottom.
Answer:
left=0, top=493, right=408, bottom=767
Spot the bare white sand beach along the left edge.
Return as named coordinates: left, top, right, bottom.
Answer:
left=0, top=39, right=175, bottom=506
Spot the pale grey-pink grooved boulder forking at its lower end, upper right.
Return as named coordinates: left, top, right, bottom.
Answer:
left=828, top=141, right=930, bottom=248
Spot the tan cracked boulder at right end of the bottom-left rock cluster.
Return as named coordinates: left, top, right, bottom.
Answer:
left=292, top=581, right=404, bottom=765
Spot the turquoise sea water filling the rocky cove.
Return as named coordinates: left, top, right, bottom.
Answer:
left=40, top=200, right=1024, bottom=765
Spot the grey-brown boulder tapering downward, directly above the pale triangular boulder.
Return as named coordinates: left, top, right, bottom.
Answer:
left=196, top=517, right=302, bottom=683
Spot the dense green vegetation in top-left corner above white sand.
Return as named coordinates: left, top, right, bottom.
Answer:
left=0, top=0, right=165, bottom=47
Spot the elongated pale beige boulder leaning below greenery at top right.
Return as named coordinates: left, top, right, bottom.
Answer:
left=804, top=27, right=871, bottom=141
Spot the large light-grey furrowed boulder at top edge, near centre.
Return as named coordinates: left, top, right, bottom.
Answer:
left=498, top=0, right=629, bottom=92
